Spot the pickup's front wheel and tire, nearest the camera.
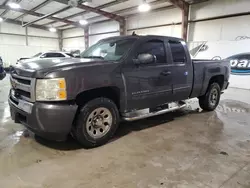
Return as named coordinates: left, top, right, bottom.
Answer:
left=72, top=97, right=120, bottom=148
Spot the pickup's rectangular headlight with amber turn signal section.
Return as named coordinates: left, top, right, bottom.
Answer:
left=36, top=78, right=67, bottom=101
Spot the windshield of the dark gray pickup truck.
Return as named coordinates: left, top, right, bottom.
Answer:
left=80, top=38, right=136, bottom=61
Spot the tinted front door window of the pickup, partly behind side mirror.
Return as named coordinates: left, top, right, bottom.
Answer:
left=137, top=40, right=166, bottom=63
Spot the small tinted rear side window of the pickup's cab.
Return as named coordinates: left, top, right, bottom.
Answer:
left=169, top=41, right=186, bottom=63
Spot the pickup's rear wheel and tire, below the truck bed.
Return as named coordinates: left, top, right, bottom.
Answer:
left=199, top=83, right=221, bottom=111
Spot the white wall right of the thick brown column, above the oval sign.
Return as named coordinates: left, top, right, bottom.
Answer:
left=188, top=0, right=250, bottom=41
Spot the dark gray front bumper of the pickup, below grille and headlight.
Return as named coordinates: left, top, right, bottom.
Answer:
left=9, top=94, right=77, bottom=141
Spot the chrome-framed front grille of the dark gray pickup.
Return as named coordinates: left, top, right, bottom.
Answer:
left=10, top=74, right=35, bottom=102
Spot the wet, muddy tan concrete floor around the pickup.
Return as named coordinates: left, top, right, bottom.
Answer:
left=0, top=75, right=250, bottom=188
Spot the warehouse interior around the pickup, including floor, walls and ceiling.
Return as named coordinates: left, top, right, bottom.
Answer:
left=0, top=0, right=250, bottom=188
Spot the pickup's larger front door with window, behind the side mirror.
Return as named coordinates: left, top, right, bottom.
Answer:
left=123, top=37, right=173, bottom=110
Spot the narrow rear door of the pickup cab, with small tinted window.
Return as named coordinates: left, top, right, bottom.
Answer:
left=168, top=40, right=194, bottom=101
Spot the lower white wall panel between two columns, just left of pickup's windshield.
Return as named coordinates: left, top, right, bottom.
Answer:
left=63, top=37, right=85, bottom=51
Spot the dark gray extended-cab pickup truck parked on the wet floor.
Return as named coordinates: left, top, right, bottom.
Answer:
left=9, top=36, right=230, bottom=147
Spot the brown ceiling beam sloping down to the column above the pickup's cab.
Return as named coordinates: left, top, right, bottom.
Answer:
left=54, top=0, right=125, bottom=22
